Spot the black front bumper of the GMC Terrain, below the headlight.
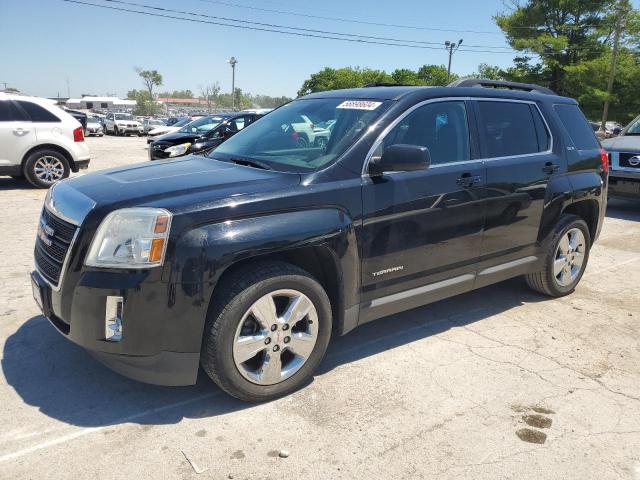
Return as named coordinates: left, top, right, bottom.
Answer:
left=31, top=270, right=204, bottom=386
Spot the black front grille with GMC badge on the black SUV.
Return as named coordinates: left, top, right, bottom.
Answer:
left=34, top=208, right=77, bottom=287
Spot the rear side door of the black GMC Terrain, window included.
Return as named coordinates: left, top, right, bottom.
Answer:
left=473, top=100, right=566, bottom=286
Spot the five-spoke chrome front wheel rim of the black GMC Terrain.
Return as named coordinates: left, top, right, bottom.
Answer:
left=233, top=290, right=318, bottom=385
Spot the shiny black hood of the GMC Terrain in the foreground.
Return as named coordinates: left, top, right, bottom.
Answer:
left=61, top=155, right=300, bottom=213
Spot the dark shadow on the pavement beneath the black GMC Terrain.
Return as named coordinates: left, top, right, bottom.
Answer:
left=2, top=279, right=544, bottom=427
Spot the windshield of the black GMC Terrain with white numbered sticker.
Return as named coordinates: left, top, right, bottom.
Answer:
left=209, top=98, right=391, bottom=173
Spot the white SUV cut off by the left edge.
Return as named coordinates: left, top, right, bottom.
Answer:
left=0, top=93, right=89, bottom=188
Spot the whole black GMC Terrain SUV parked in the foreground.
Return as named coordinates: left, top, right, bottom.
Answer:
left=32, top=80, right=607, bottom=400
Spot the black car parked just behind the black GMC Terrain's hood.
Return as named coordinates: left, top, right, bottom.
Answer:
left=149, top=113, right=260, bottom=160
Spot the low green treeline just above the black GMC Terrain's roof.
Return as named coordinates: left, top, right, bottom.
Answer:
left=298, top=65, right=458, bottom=96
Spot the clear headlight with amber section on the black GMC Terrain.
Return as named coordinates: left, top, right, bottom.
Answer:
left=85, top=208, right=171, bottom=268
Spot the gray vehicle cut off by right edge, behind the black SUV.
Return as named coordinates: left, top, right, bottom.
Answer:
left=602, top=116, right=640, bottom=199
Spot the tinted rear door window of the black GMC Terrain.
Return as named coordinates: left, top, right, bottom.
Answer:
left=477, top=101, right=548, bottom=158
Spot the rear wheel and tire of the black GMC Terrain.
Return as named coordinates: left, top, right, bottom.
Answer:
left=525, top=214, right=591, bottom=297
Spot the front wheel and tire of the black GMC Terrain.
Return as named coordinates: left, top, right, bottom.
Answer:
left=200, top=262, right=332, bottom=402
